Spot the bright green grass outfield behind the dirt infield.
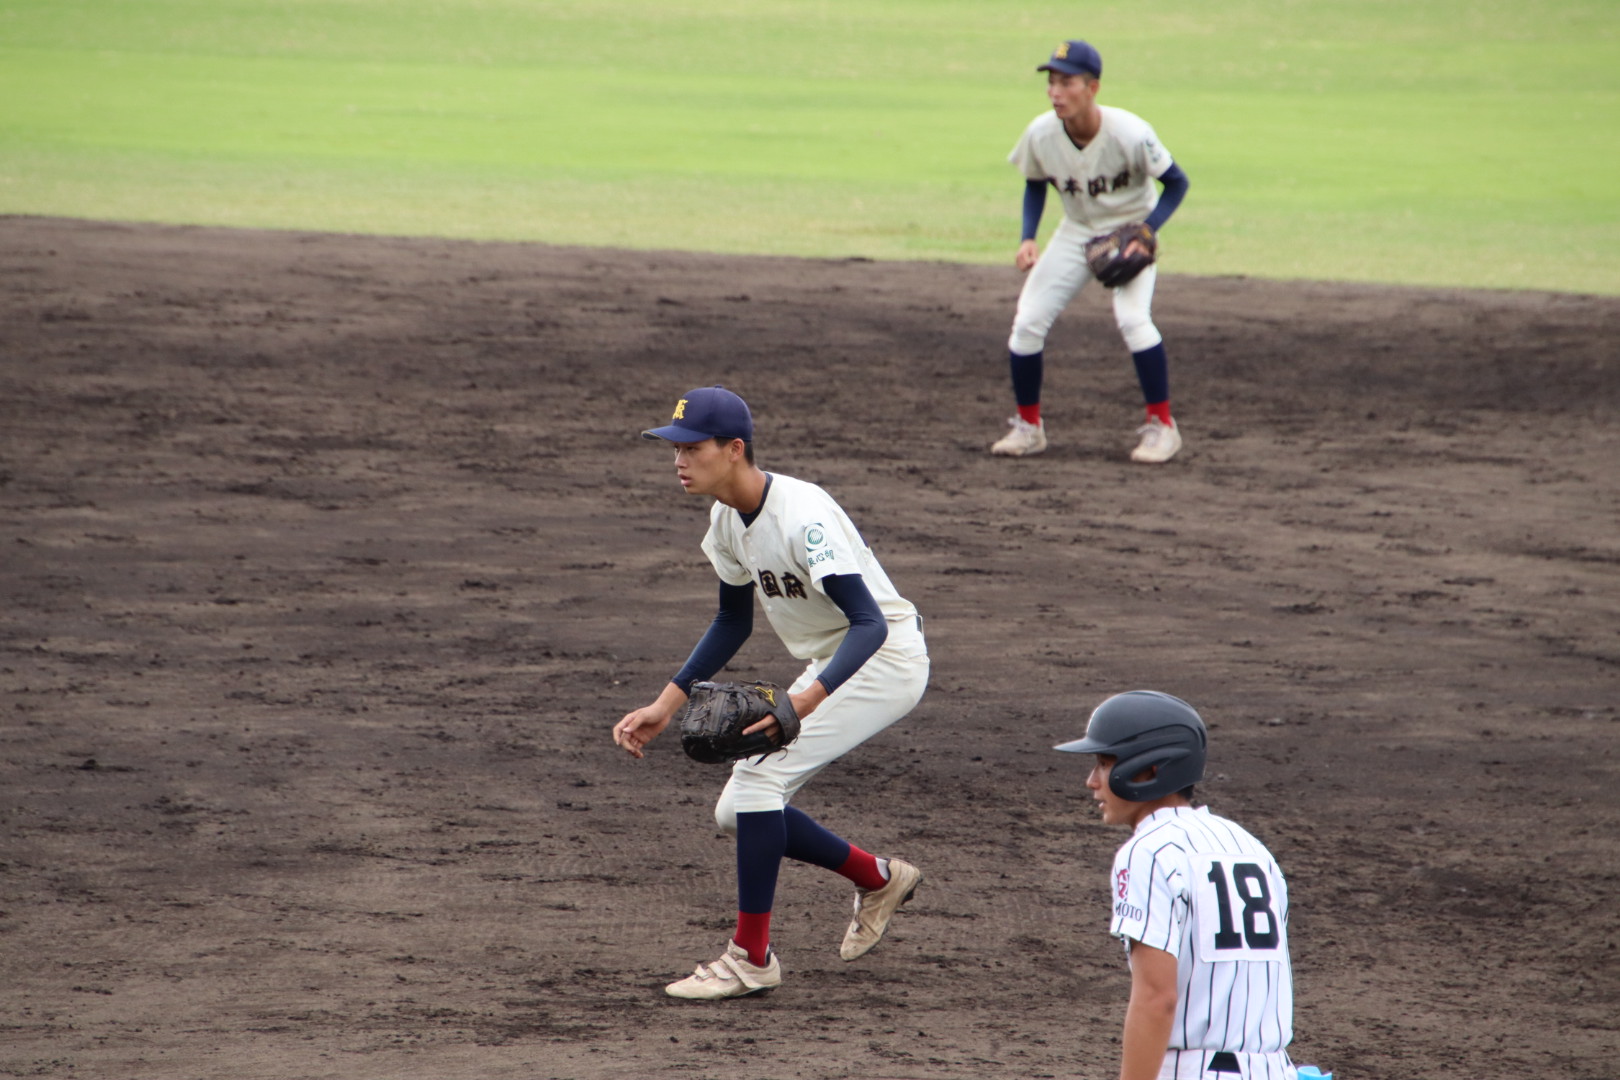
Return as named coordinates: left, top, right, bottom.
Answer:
left=0, top=0, right=1620, bottom=295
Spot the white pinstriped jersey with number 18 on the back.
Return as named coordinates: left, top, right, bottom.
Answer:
left=1110, top=806, right=1294, bottom=1054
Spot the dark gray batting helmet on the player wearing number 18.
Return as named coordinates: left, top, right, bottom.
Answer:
left=1053, top=690, right=1209, bottom=803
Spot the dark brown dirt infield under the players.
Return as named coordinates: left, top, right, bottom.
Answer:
left=0, top=219, right=1620, bottom=1080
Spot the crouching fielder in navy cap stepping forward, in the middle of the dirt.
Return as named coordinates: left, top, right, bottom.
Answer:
left=614, top=387, right=928, bottom=999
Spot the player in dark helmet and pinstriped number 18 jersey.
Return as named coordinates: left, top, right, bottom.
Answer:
left=1056, top=690, right=1296, bottom=1080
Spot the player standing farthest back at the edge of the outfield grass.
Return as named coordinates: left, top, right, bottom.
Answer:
left=990, top=40, right=1189, bottom=463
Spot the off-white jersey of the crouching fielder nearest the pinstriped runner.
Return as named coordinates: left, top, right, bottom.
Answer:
left=703, top=473, right=917, bottom=661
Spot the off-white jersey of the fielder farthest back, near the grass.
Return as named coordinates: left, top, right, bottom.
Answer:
left=1008, top=105, right=1173, bottom=236
